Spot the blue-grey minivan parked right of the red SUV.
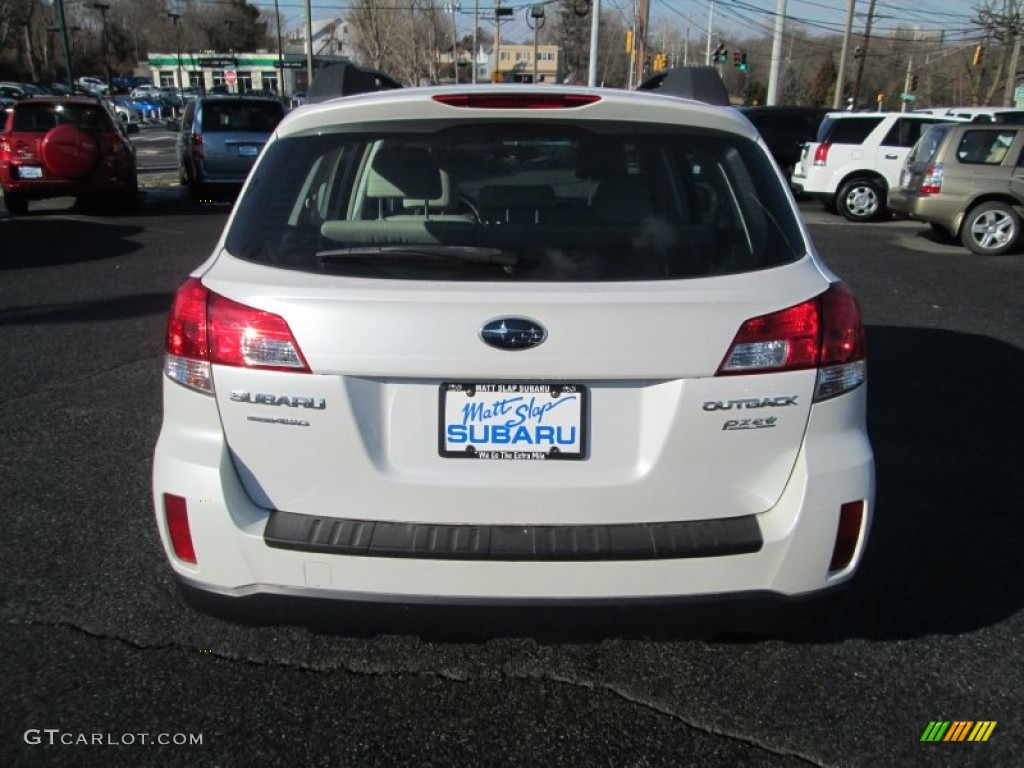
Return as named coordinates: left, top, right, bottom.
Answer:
left=168, top=96, right=285, bottom=199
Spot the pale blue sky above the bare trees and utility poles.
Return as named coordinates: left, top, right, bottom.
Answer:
left=250, top=0, right=978, bottom=47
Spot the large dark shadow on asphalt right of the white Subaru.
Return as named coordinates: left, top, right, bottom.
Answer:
left=812, top=326, right=1024, bottom=640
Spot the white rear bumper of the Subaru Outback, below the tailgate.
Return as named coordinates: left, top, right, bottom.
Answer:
left=154, top=376, right=874, bottom=629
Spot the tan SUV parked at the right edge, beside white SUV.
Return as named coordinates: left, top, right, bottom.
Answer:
left=889, top=123, right=1024, bottom=256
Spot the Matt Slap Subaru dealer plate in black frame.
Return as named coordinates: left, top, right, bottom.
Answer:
left=438, top=382, right=587, bottom=461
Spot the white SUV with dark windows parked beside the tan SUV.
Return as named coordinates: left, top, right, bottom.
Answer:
left=791, top=112, right=956, bottom=221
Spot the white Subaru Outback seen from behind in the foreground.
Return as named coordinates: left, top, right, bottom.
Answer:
left=153, top=85, right=873, bottom=631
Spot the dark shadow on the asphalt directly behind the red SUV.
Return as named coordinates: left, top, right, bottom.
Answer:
left=0, top=217, right=143, bottom=270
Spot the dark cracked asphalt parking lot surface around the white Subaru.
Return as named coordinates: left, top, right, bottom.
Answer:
left=0, top=188, right=1024, bottom=766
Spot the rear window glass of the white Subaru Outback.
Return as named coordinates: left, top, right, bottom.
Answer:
left=226, top=123, right=806, bottom=282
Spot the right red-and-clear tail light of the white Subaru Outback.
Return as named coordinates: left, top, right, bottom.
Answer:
left=717, top=283, right=867, bottom=401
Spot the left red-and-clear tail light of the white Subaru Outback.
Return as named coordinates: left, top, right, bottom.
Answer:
left=164, top=278, right=309, bottom=393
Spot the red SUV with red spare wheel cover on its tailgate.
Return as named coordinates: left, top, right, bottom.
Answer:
left=0, top=96, right=138, bottom=214
